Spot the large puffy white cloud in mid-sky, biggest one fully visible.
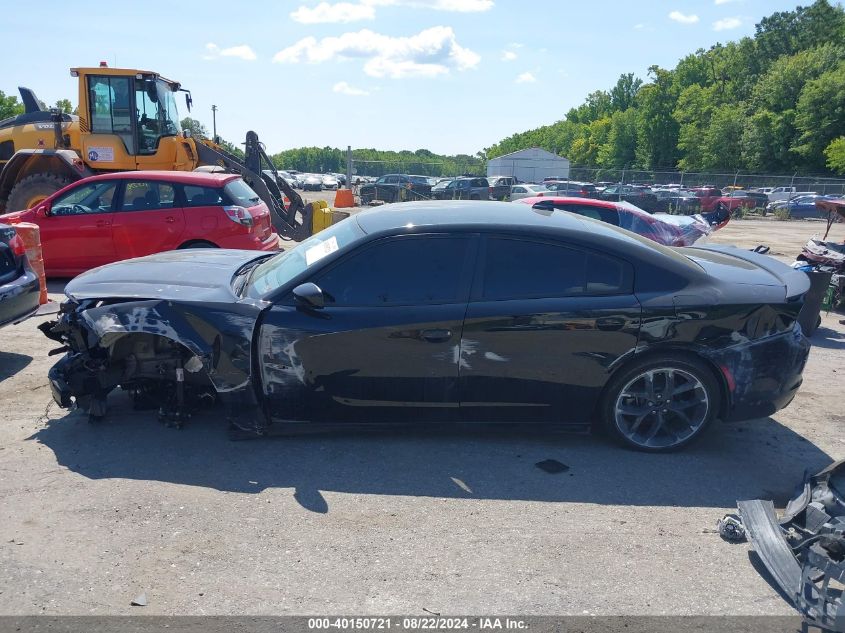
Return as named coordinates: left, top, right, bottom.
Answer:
left=273, top=26, right=481, bottom=79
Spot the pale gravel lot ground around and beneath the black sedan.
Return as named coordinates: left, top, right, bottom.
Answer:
left=0, top=210, right=845, bottom=615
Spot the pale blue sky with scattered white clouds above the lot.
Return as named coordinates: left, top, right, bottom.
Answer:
left=0, top=0, right=809, bottom=154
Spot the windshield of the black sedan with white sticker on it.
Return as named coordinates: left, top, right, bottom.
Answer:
left=247, top=218, right=364, bottom=299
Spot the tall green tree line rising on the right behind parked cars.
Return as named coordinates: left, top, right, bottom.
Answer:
left=482, top=0, right=845, bottom=174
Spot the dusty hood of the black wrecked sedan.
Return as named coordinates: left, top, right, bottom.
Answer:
left=65, top=248, right=268, bottom=303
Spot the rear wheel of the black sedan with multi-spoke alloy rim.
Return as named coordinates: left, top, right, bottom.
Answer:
left=600, top=354, right=721, bottom=453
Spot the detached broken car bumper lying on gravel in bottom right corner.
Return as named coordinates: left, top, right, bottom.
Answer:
left=738, top=460, right=845, bottom=632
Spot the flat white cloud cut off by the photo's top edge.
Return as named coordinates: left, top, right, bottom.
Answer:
left=290, top=0, right=494, bottom=24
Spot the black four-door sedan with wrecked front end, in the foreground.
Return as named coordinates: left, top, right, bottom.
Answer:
left=43, top=202, right=809, bottom=451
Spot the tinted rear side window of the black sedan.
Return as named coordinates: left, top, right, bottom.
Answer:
left=481, top=237, right=633, bottom=301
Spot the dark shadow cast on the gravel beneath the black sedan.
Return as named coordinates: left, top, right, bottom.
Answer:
left=28, top=394, right=831, bottom=512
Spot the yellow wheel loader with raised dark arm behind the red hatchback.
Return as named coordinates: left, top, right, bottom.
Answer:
left=0, top=62, right=312, bottom=241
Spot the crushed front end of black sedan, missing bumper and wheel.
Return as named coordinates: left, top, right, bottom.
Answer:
left=39, top=297, right=266, bottom=433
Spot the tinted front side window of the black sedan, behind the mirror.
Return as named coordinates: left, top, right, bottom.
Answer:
left=314, top=236, right=470, bottom=306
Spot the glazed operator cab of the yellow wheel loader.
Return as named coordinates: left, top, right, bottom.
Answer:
left=71, top=66, right=182, bottom=170
